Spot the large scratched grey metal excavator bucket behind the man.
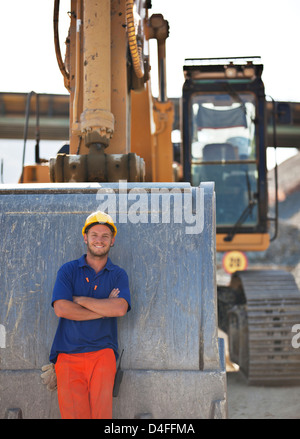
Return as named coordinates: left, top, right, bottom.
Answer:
left=0, top=182, right=227, bottom=419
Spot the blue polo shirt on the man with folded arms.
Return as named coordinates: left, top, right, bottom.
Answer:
left=50, top=255, right=131, bottom=363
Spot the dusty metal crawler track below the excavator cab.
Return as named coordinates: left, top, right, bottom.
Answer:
left=231, top=270, right=300, bottom=385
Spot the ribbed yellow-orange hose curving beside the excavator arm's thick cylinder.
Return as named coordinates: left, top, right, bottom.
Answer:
left=126, top=0, right=144, bottom=78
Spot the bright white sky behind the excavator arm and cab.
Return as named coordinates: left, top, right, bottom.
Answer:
left=0, top=0, right=300, bottom=182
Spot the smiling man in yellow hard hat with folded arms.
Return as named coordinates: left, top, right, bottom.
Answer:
left=50, top=211, right=131, bottom=419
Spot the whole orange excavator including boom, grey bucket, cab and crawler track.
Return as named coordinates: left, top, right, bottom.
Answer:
left=0, top=0, right=300, bottom=419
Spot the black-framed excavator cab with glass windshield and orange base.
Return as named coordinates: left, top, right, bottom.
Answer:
left=182, top=59, right=269, bottom=251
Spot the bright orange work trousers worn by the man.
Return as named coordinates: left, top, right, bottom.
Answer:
left=55, top=349, right=116, bottom=419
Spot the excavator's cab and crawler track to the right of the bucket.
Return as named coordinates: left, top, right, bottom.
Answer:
left=181, top=57, right=300, bottom=385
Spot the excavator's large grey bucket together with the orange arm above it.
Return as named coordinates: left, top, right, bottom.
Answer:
left=0, top=0, right=227, bottom=420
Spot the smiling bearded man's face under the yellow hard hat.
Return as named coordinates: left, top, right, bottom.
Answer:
left=84, top=224, right=115, bottom=257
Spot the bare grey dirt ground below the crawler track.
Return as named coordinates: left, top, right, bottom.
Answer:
left=227, top=372, right=300, bottom=419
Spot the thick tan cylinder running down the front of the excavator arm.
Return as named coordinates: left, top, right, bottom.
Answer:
left=81, top=0, right=114, bottom=147
